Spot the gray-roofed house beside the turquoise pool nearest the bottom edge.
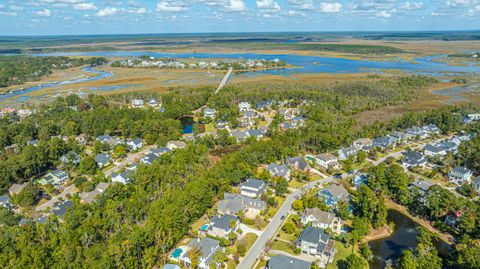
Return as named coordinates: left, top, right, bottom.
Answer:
left=179, top=237, right=223, bottom=269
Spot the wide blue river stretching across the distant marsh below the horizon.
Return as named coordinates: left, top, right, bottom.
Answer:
left=34, top=51, right=480, bottom=75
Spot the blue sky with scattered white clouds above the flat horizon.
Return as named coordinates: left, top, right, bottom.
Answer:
left=0, top=0, right=480, bottom=35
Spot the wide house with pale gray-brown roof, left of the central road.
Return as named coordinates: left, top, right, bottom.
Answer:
left=217, top=193, right=267, bottom=216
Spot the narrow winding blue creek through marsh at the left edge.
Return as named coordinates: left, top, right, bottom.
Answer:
left=0, top=66, right=112, bottom=100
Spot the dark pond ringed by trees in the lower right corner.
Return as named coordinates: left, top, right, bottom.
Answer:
left=369, top=210, right=448, bottom=269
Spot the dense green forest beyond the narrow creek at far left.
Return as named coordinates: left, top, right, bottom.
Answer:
left=0, top=56, right=108, bottom=87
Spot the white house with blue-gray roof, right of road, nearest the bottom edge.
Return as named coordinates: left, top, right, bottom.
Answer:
left=297, top=226, right=335, bottom=267
